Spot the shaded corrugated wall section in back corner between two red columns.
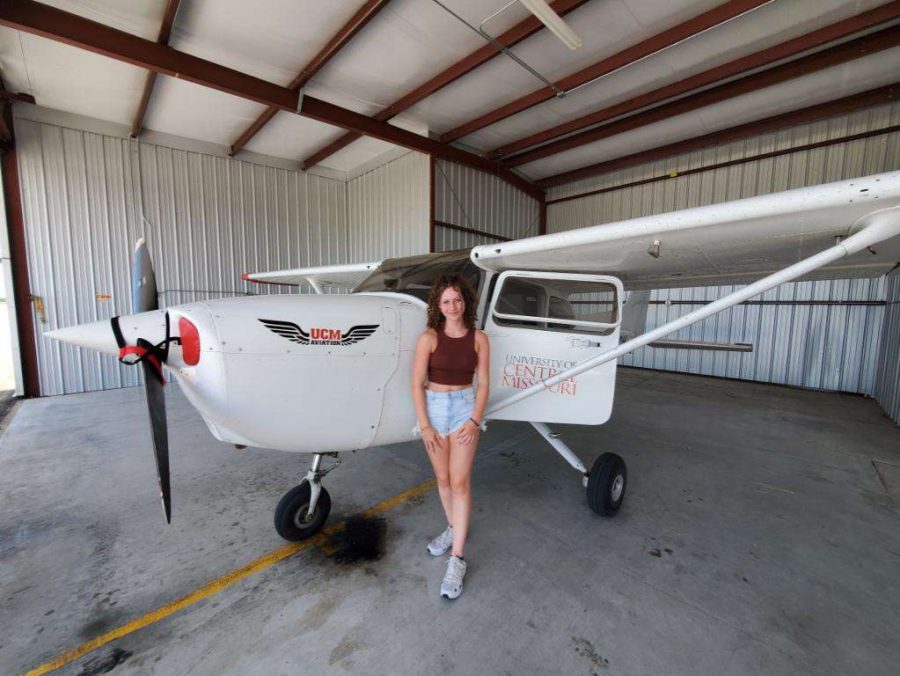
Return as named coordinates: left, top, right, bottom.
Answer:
left=434, top=160, right=539, bottom=251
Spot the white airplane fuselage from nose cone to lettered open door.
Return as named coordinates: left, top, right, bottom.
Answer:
left=48, top=273, right=621, bottom=453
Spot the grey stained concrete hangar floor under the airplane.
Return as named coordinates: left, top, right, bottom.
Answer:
left=0, top=369, right=900, bottom=676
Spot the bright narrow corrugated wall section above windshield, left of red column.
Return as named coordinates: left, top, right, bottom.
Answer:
left=347, top=152, right=430, bottom=263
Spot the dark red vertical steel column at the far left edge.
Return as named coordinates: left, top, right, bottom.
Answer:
left=2, top=142, right=41, bottom=397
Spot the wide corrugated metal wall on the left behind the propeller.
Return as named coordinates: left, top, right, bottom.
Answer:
left=16, top=119, right=349, bottom=395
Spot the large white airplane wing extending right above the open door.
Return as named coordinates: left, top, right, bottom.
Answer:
left=471, top=171, right=900, bottom=289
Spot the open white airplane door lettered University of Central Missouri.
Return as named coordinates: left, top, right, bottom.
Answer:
left=484, top=271, right=622, bottom=425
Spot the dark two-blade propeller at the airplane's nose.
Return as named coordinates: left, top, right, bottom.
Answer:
left=131, top=237, right=172, bottom=523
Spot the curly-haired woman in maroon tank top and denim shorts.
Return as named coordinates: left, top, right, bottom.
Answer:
left=412, top=276, right=490, bottom=599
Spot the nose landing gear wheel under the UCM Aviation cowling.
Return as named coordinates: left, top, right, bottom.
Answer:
left=275, top=453, right=341, bottom=542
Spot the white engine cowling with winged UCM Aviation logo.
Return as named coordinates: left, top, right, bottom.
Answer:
left=168, top=293, right=426, bottom=452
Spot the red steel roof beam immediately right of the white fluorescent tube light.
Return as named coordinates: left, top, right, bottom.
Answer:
left=440, top=0, right=771, bottom=143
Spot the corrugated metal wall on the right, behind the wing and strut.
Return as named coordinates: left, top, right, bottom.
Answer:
left=548, top=103, right=900, bottom=394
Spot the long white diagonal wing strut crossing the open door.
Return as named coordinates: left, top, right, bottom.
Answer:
left=484, top=207, right=900, bottom=418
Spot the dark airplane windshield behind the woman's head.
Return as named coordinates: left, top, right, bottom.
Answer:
left=353, top=249, right=482, bottom=300
